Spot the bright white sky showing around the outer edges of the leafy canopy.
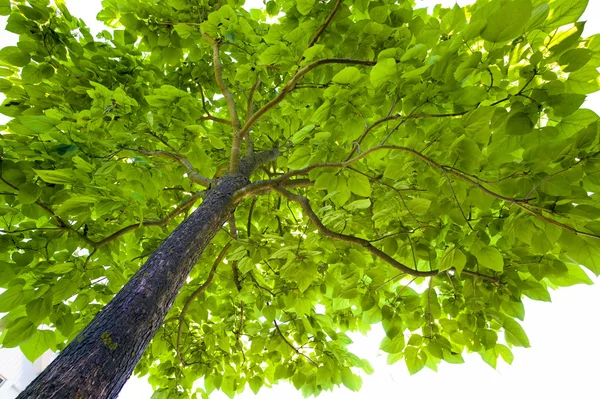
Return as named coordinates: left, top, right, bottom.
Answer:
left=0, top=0, right=600, bottom=399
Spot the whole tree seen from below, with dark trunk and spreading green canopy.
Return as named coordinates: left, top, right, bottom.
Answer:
left=0, top=0, right=600, bottom=398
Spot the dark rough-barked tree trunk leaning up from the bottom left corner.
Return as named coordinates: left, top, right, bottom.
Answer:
left=18, top=174, right=248, bottom=399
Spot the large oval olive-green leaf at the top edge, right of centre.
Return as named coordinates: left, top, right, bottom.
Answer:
left=481, top=0, right=533, bottom=43
